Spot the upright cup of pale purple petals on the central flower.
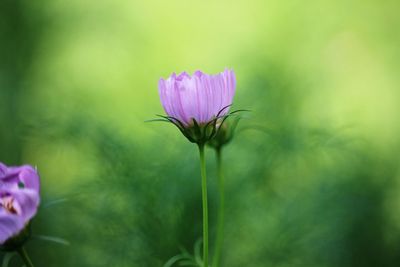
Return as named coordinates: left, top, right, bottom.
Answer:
left=158, top=69, right=236, bottom=128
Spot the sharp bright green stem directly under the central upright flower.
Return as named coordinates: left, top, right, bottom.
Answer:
left=199, top=144, right=208, bottom=267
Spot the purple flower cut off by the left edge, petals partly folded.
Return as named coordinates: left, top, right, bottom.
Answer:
left=0, top=162, right=40, bottom=244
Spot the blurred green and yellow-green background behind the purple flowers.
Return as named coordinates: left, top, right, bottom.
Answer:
left=0, top=0, right=400, bottom=267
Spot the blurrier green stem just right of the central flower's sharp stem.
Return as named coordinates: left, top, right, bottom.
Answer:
left=213, top=148, right=225, bottom=267
